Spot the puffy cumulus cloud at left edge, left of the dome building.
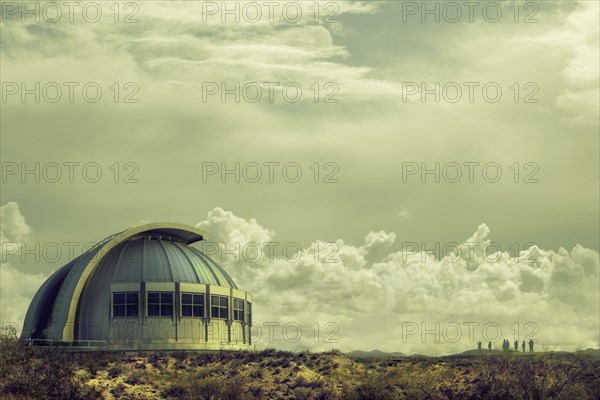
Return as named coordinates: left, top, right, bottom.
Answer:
left=0, top=202, right=46, bottom=329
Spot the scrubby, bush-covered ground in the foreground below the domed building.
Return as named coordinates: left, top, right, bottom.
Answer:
left=0, top=339, right=600, bottom=400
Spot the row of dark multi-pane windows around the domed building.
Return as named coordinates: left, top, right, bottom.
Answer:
left=113, top=292, right=250, bottom=322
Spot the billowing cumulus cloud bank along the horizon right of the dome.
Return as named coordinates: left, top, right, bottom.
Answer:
left=197, top=208, right=599, bottom=354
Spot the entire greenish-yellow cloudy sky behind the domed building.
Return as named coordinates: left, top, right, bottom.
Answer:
left=0, top=1, right=600, bottom=354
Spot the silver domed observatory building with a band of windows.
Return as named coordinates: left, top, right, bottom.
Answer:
left=21, top=223, right=253, bottom=350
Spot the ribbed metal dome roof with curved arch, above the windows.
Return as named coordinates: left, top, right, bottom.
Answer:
left=23, top=223, right=237, bottom=341
